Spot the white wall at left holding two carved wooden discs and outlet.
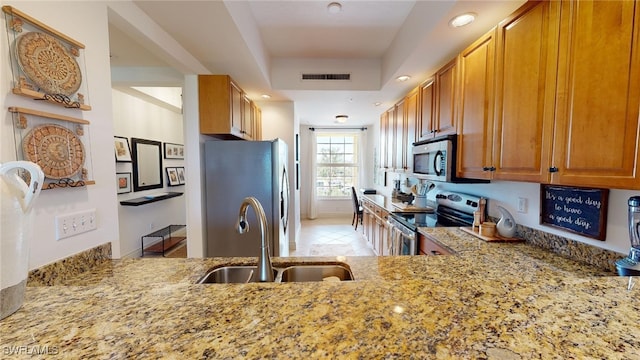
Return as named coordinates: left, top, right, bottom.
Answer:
left=0, top=1, right=120, bottom=269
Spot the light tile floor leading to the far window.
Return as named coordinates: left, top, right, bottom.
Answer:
left=289, top=215, right=375, bottom=256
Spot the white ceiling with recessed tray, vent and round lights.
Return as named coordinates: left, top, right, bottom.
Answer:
left=109, top=0, right=524, bottom=126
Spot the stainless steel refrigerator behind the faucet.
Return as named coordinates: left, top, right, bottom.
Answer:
left=204, top=139, right=289, bottom=257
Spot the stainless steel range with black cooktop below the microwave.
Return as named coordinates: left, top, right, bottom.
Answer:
left=387, top=191, right=486, bottom=255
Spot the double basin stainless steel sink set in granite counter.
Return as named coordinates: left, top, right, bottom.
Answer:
left=197, top=263, right=353, bottom=284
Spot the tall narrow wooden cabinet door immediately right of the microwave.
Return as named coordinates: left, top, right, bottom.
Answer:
left=457, top=29, right=495, bottom=179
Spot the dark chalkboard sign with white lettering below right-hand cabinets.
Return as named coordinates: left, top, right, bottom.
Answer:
left=540, top=185, right=609, bottom=240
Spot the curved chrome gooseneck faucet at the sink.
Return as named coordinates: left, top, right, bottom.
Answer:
left=236, top=196, right=274, bottom=282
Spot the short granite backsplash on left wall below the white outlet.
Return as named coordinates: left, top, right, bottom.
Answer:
left=27, top=243, right=111, bottom=286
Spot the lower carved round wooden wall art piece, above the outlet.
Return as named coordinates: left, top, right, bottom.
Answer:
left=22, top=124, right=84, bottom=179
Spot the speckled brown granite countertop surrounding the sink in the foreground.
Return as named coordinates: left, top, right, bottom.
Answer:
left=0, top=228, right=640, bottom=359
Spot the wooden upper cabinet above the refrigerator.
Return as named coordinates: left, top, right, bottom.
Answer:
left=198, top=75, right=254, bottom=140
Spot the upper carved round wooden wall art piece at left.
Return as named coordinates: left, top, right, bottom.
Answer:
left=16, top=32, right=82, bottom=96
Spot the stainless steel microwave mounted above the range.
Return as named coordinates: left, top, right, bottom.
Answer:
left=413, top=135, right=488, bottom=183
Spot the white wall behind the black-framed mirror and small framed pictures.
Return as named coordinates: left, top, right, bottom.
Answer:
left=112, top=90, right=186, bottom=257
